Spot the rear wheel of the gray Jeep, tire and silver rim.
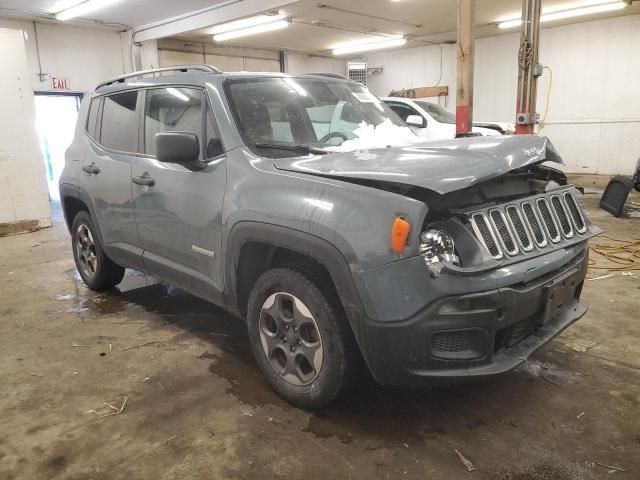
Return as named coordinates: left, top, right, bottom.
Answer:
left=71, top=210, right=124, bottom=292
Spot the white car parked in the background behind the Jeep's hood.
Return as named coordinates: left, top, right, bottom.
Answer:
left=380, top=97, right=514, bottom=140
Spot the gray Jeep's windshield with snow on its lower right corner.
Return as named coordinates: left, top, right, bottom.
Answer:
left=225, top=77, right=418, bottom=157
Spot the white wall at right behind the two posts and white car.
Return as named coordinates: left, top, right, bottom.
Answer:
left=366, top=15, right=640, bottom=175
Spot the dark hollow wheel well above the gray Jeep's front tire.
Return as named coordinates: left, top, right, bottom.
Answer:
left=236, top=242, right=343, bottom=316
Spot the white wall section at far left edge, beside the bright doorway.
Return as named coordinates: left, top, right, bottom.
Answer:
left=0, top=28, right=51, bottom=227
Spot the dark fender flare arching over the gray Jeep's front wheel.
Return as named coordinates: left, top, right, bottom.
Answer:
left=224, top=221, right=363, bottom=322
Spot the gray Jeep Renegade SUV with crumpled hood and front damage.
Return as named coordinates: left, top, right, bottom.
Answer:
left=60, top=65, right=600, bottom=407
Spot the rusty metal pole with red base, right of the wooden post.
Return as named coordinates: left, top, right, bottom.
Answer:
left=516, top=0, right=542, bottom=135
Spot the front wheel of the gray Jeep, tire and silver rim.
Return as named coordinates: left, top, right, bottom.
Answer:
left=247, top=268, right=358, bottom=408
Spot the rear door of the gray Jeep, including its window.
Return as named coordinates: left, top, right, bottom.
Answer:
left=79, top=90, right=142, bottom=267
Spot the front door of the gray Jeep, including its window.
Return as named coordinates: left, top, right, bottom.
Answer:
left=132, top=86, right=226, bottom=302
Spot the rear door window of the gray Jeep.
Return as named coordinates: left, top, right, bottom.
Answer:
left=100, top=91, right=138, bottom=152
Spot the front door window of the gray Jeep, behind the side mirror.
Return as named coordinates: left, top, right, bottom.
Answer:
left=144, top=87, right=205, bottom=155
